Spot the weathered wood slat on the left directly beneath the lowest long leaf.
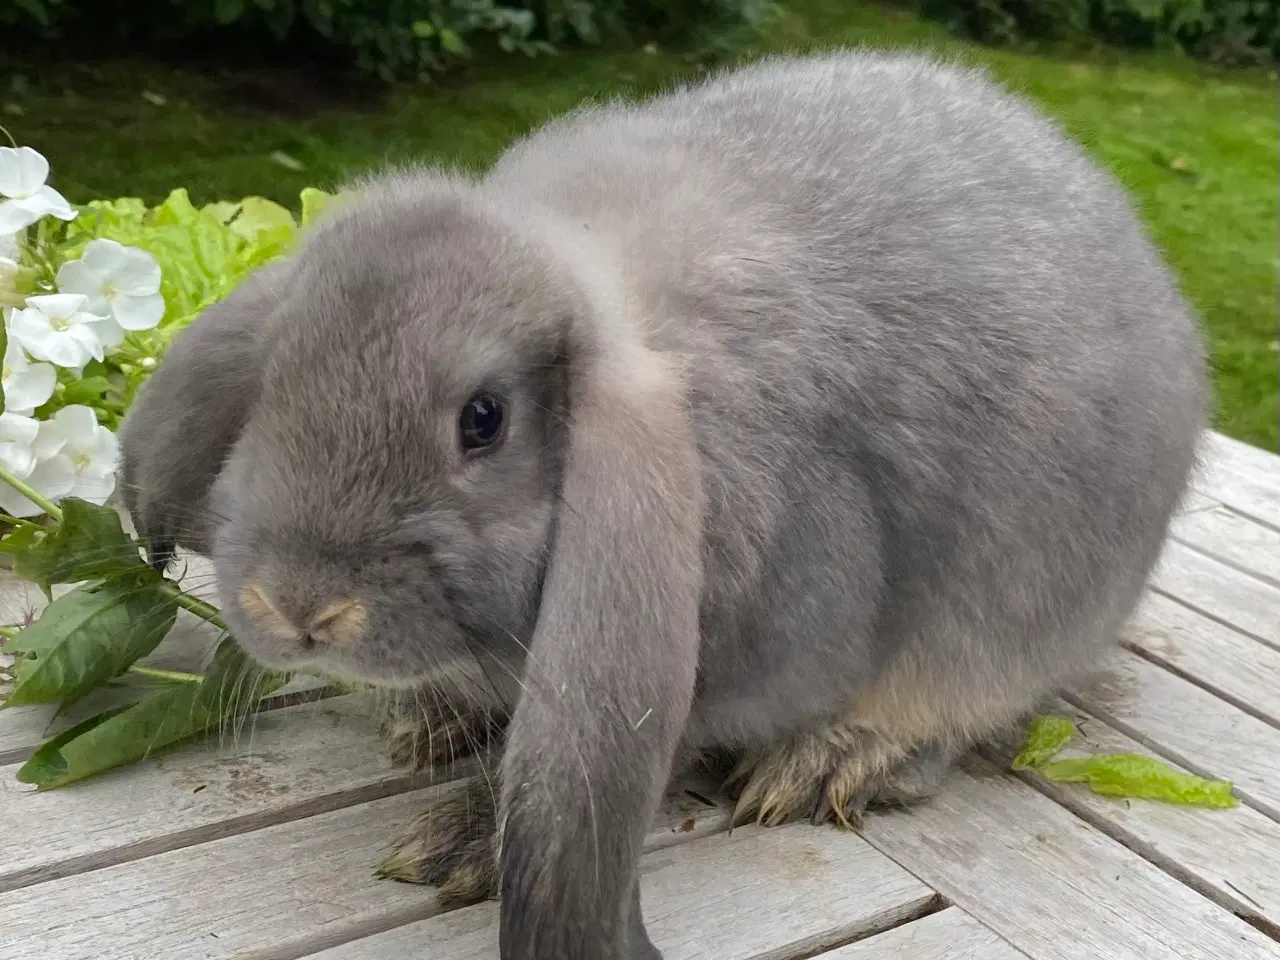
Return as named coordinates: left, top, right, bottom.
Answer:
left=0, top=696, right=445, bottom=890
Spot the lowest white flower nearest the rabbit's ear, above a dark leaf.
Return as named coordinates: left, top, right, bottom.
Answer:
left=27, top=403, right=119, bottom=512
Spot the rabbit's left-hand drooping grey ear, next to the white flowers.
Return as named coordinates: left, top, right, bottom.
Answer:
left=119, top=261, right=289, bottom=563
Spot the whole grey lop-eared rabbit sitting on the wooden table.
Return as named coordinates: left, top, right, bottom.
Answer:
left=123, top=51, right=1208, bottom=960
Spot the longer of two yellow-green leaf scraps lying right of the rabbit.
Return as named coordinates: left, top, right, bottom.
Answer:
left=1039, top=754, right=1239, bottom=809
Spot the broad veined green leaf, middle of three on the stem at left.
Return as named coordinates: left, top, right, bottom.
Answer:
left=0, top=578, right=178, bottom=707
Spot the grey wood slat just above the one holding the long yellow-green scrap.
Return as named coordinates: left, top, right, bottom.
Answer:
left=1064, top=650, right=1280, bottom=820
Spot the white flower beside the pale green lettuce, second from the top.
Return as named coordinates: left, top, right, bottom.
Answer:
left=58, top=239, right=164, bottom=330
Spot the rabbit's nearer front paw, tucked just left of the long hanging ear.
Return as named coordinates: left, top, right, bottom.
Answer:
left=375, top=777, right=498, bottom=906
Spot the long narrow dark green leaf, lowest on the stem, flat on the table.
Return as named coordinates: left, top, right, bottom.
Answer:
left=18, top=640, right=288, bottom=790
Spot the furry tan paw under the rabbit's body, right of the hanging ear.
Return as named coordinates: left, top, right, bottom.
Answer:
left=726, top=727, right=956, bottom=828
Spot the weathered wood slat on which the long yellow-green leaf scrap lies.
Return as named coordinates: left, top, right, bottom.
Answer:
left=993, top=701, right=1280, bottom=933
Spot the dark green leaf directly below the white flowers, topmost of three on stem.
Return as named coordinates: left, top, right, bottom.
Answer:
left=13, top=497, right=150, bottom=588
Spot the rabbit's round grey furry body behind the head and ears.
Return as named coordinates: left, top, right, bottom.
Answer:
left=481, top=54, right=1204, bottom=745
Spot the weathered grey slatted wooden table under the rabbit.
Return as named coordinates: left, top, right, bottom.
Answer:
left=0, top=435, right=1280, bottom=960
